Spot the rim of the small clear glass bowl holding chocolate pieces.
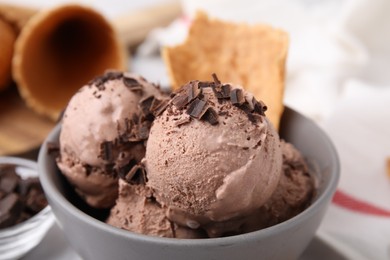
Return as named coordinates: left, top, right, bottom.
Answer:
left=0, top=156, right=51, bottom=239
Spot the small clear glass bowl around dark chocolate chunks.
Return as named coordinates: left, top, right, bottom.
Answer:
left=0, top=157, right=54, bottom=260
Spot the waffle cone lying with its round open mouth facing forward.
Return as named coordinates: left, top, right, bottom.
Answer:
left=12, top=5, right=127, bottom=119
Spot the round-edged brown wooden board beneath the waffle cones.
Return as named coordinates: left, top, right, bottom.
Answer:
left=0, top=86, right=55, bottom=155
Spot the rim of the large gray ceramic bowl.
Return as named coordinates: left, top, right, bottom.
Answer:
left=38, top=107, right=340, bottom=247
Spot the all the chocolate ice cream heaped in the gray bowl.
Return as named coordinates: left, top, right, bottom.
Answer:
left=57, top=72, right=315, bottom=238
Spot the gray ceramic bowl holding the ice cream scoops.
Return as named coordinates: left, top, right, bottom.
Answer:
left=38, top=108, right=339, bottom=260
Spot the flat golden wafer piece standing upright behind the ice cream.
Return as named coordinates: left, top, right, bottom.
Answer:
left=162, top=12, right=288, bottom=129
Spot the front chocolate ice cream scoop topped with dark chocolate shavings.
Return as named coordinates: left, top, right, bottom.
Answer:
left=144, top=76, right=282, bottom=235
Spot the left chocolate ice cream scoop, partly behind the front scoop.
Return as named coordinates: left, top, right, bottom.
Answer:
left=57, top=72, right=168, bottom=208
